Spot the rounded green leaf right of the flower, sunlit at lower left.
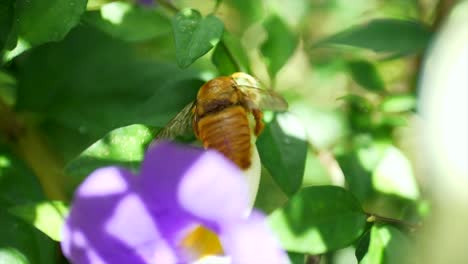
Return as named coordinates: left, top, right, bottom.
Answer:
left=269, top=186, right=366, bottom=255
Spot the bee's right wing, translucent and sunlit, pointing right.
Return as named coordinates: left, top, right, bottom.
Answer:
left=238, top=85, right=288, bottom=111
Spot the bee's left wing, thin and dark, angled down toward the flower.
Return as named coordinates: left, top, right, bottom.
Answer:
left=156, top=101, right=195, bottom=140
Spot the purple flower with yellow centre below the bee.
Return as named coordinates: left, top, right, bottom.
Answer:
left=62, top=142, right=287, bottom=264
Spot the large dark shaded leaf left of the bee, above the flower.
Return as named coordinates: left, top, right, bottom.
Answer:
left=16, top=27, right=202, bottom=161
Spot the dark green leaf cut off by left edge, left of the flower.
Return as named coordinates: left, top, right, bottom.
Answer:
left=0, top=145, right=44, bottom=208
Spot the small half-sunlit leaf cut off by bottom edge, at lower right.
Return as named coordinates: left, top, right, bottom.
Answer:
left=359, top=225, right=417, bottom=264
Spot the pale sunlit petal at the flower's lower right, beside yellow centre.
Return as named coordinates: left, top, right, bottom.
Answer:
left=221, top=211, right=289, bottom=264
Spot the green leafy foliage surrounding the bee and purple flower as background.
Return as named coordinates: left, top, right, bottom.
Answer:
left=0, top=0, right=466, bottom=264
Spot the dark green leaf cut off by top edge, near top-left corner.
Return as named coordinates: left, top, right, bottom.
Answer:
left=15, top=0, right=87, bottom=46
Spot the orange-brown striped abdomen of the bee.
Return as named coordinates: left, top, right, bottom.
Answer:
left=198, top=106, right=251, bottom=169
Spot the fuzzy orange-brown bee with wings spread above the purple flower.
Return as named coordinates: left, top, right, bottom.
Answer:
left=156, top=72, right=288, bottom=170
